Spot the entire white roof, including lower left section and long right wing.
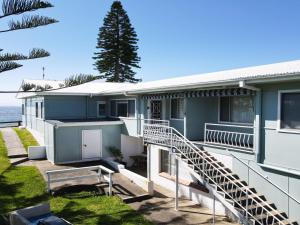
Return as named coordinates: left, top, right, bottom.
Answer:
left=17, top=60, right=300, bottom=98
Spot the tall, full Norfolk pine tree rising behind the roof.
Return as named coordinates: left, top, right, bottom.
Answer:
left=93, top=1, right=140, bottom=83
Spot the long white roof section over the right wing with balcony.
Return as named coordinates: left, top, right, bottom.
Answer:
left=128, top=60, right=300, bottom=93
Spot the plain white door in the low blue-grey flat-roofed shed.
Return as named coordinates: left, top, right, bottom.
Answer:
left=82, top=130, right=102, bottom=159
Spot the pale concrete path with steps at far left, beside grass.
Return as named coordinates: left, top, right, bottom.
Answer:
left=0, top=128, right=30, bottom=165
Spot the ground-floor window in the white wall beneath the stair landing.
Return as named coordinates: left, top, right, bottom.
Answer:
left=160, top=149, right=176, bottom=176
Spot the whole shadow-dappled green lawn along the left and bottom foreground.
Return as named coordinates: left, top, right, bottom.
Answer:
left=0, top=132, right=152, bottom=225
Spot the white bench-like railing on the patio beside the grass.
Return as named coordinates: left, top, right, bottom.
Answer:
left=46, top=166, right=114, bottom=196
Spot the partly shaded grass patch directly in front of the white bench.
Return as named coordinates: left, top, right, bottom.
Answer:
left=51, top=185, right=152, bottom=225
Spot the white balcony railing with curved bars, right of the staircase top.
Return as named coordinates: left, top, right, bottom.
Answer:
left=204, top=123, right=254, bottom=151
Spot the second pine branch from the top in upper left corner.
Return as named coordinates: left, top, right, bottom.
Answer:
left=0, top=15, right=58, bottom=33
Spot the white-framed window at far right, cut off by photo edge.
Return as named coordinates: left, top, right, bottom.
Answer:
left=279, top=92, right=300, bottom=129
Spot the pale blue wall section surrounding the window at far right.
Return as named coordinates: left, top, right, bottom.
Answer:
left=261, top=82, right=300, bottom=172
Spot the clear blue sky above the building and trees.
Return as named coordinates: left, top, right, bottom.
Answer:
left=0, top=0, right=300, bottom=106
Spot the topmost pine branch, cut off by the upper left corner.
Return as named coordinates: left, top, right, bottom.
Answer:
left=0, top=0, right=53, bottom=18
